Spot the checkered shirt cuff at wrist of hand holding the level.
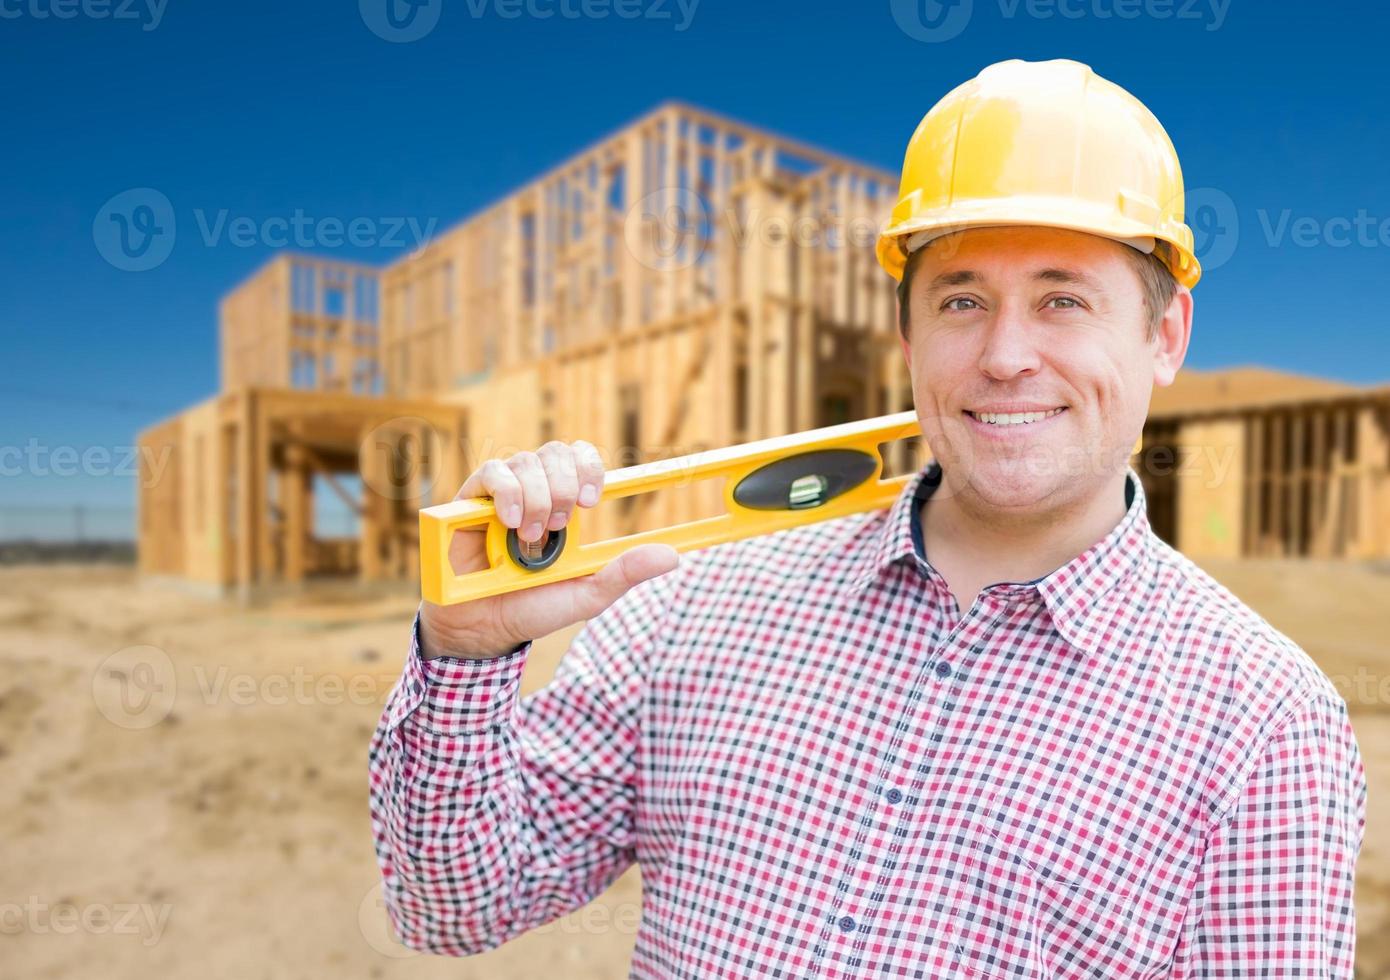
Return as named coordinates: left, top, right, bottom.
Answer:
left=402, top=612, right=532, bottom=735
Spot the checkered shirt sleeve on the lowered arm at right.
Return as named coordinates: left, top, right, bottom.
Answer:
left=1173, top=683, right=1366, bottom=980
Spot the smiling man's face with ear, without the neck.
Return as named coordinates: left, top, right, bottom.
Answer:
left=904, top=227, right=1191, bottom=516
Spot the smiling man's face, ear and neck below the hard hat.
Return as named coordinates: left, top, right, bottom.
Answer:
left=899, top=227, right=1193, bottom=610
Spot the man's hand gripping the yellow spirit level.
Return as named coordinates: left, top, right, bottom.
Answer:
left=420, top=439, right=678, bottom=659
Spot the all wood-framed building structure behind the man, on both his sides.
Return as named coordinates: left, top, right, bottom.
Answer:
left=139, top=104, right=1390, bottom=595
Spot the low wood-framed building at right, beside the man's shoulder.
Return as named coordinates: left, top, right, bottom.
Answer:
left=1137, top=367, right=1390, bottom=559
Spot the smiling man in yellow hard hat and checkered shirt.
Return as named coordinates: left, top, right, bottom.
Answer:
left=371, top=61, right=1365, bottom=977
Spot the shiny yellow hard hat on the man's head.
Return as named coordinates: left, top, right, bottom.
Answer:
left=877, top=60, right=1201, bottom=286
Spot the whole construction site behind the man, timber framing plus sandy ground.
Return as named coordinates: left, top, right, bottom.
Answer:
left=0, top=103, right=1390, bottom=980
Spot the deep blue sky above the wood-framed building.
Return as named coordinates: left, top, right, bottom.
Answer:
left=0, top=0, right=1390, bottom=537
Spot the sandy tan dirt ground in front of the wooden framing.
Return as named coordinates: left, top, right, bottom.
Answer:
left=0, top=562, right=1390, bottom=980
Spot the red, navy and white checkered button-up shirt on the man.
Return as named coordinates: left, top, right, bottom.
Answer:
left=370, top=463, right=1366, bottom=979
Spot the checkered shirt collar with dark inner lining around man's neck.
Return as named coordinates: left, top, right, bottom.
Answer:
left=849, top=460, right=1152, bottom=649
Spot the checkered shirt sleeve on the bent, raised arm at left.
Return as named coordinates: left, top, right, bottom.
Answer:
left=368, top=571, right=678, bottom=956
